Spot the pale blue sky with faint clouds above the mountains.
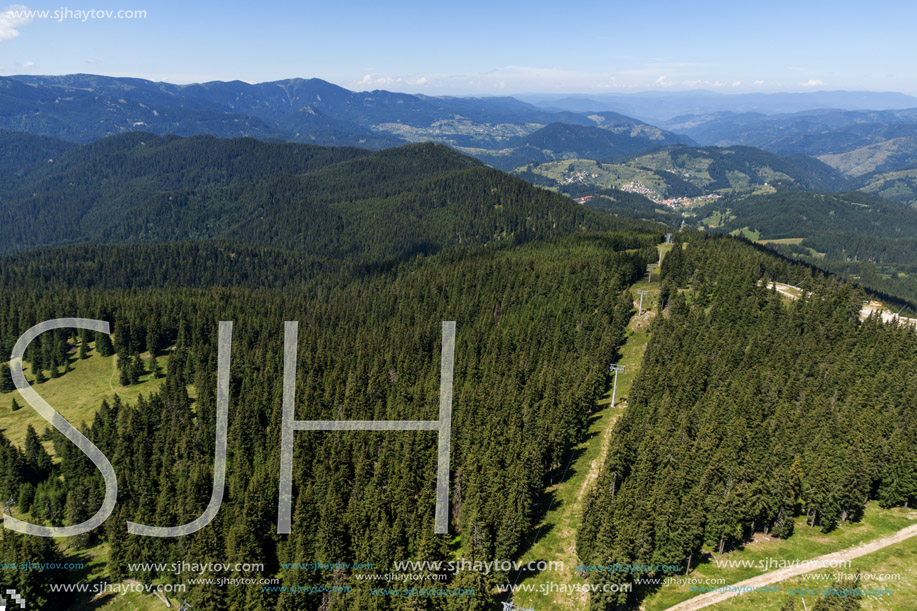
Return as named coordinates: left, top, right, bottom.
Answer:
left=0, top=0, right=917, bottom=95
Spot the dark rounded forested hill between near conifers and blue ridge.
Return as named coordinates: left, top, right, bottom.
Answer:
left=0, top=133, right=636, bottom=261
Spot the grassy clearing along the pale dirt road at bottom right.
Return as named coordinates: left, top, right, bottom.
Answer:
left=644, top=502, right=917, bottom=611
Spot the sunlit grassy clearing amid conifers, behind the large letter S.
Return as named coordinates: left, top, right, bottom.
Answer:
left=0, top=344, right=169, bottom=452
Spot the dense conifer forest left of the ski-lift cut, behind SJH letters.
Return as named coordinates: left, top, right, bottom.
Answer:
left=0, top=233, right=659, bottom=610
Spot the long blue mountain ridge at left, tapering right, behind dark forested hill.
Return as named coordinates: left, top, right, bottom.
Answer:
left=0, top=74, right=693, bottom=169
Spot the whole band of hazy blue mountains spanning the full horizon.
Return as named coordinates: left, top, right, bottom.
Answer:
left=8, top=74, right=917, bottom=203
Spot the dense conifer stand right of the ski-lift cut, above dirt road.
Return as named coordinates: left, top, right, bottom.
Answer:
left=577, top=236, right=917, bottom=609
